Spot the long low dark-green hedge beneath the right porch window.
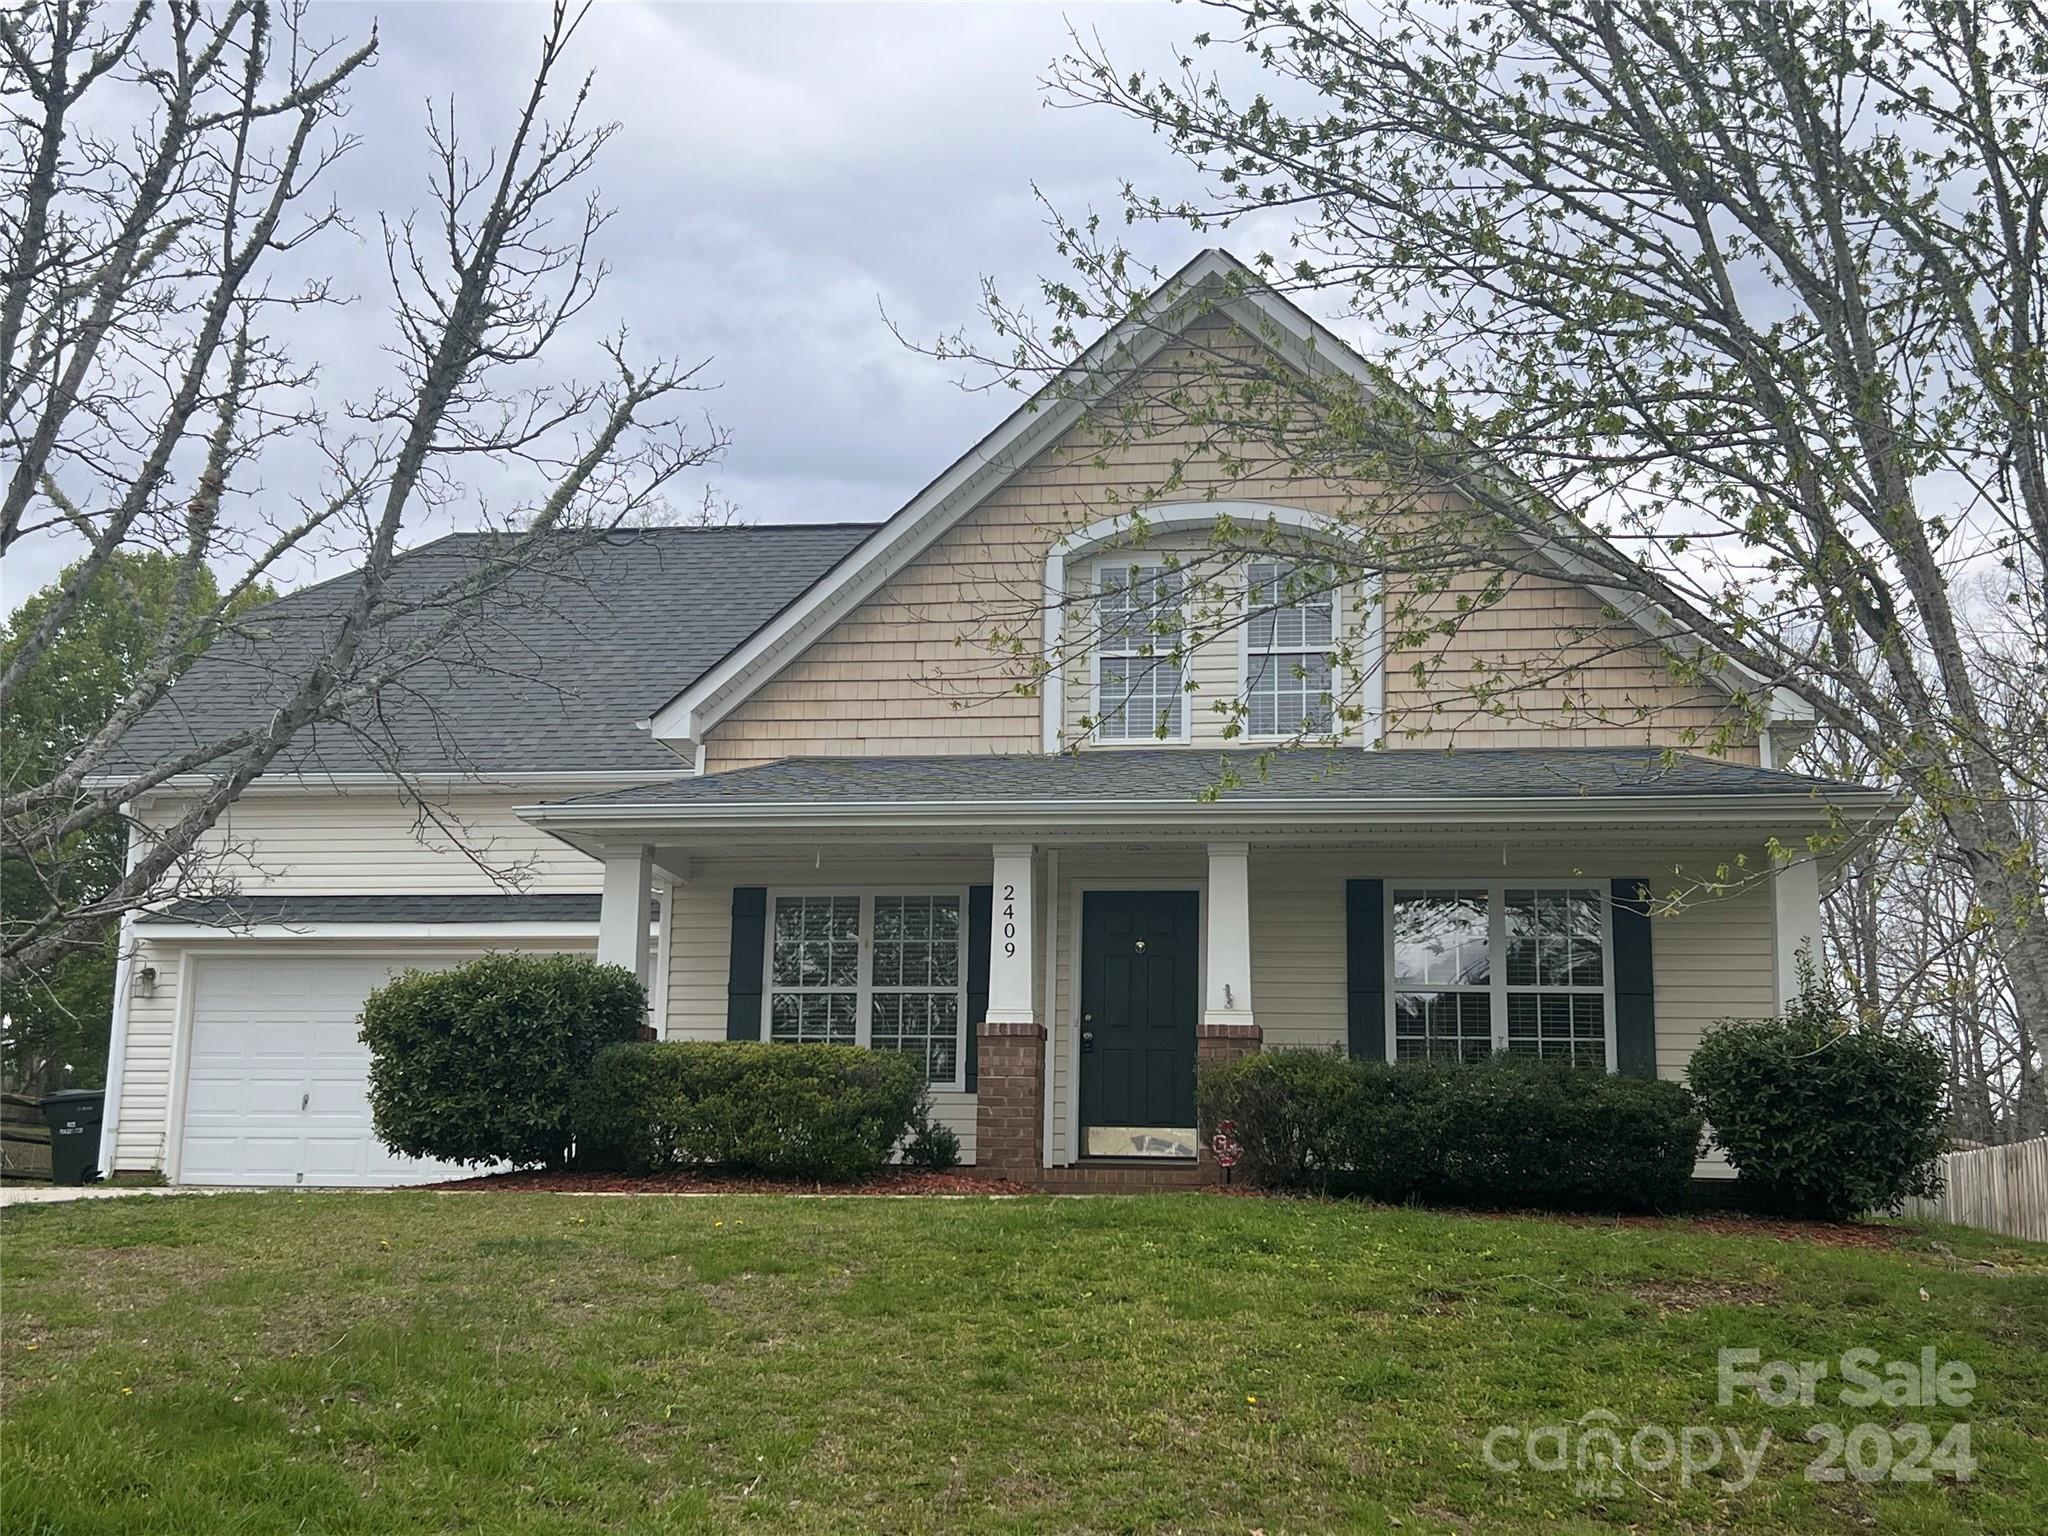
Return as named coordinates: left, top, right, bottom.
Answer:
left=1198, top=1051, right=1700, bottom=1210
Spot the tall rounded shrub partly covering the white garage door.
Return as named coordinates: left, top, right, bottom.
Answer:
left=360, top=954, right=647, bottom=1167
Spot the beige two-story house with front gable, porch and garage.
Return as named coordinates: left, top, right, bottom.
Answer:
left=102, top=252, right=1876, bottom=1184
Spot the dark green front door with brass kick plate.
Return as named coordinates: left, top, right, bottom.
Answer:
left=1081, top=891, right=1202, bottom=1157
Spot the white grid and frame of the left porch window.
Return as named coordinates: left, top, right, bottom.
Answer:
left=762, top=887, right=969, bottom=1092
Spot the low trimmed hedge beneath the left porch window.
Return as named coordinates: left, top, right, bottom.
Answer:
left=573, top=1040, right=926, bottom=1182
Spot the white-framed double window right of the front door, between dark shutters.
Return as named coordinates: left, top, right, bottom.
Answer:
left=1386, top=881, right=1614, bottom=1067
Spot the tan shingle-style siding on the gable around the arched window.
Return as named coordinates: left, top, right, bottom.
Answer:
left=705, top=329, right=1755, bottom=772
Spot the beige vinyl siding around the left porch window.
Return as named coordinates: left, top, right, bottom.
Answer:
left=668, top=858, right=1015, bottom=1163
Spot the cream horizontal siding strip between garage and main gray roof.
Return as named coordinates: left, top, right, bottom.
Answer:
left=143, top=788, right=604, bottom=895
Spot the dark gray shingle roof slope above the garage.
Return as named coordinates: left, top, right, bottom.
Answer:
left=123, top=524, right=874, bottom=774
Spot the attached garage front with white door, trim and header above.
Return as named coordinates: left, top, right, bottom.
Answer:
left=109, top=895, right=596, bottom=1188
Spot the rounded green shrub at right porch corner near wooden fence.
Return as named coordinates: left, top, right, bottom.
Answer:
left=1686, top=985, right=1946, bottom=1221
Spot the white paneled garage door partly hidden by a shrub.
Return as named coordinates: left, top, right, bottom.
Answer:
left=178, top=954, right=509, bottom=1186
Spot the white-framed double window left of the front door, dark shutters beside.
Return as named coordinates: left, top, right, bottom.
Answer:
left=768, top=891, right=967, bottom=1087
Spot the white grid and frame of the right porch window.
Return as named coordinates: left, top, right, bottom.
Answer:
left=1380, top=877, right=1616, bottom=1071
